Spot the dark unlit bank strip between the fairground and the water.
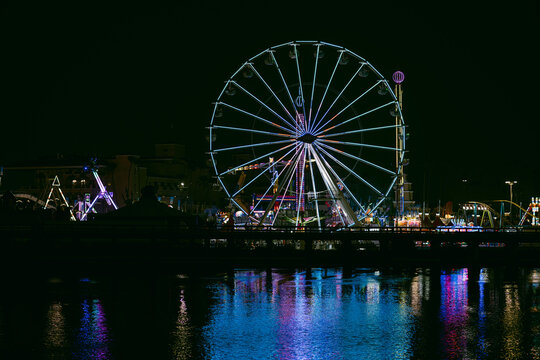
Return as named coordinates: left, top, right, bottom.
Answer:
left=0, top=223, right=540, bottom=269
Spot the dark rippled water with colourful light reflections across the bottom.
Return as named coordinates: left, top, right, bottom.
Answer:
left=0, top=268, right=540, bottom=360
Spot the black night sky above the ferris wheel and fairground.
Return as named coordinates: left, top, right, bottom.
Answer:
left=0, top=1, right=540, bottom=203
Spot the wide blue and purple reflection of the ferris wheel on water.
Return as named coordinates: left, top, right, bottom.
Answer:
left=198, top=269, right=413, bottom=360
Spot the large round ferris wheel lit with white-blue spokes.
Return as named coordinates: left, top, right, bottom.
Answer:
left=209, top=41, right=405, bottom=227
